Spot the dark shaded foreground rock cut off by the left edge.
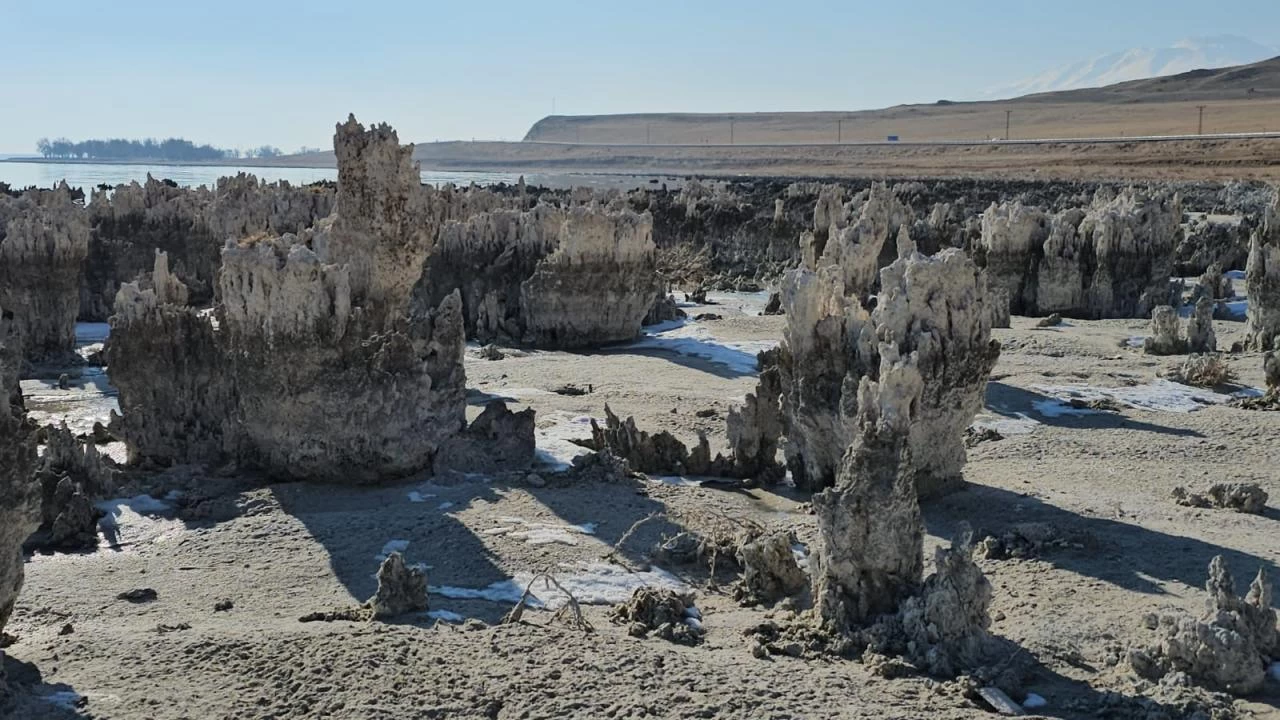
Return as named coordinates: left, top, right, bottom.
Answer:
left=0, top=310, right=40, bottom=676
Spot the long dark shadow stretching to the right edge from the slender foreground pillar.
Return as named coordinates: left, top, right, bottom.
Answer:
left=922, top=484, right=1280, bottom=594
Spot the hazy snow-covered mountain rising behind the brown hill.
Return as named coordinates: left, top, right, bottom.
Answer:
left=986, top=35, right=1280, bottom=99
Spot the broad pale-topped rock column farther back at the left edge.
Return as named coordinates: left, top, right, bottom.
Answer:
left=0, top=182, right=88, bottom=363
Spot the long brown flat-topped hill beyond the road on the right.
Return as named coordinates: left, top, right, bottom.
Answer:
left=525, top=58, right=1280, bottom=145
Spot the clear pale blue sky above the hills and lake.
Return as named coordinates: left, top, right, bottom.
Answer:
left=0, top=0, right=1280, bottom=152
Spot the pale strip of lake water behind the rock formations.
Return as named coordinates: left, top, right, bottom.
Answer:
left=0, top=161, right=682, bottom=192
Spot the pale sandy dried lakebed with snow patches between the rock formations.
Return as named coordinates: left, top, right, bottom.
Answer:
left=6, top=302, right=1280, bottom=720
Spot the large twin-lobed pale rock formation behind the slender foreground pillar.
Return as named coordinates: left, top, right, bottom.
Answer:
left=778, top=247, right=1000, bottom=496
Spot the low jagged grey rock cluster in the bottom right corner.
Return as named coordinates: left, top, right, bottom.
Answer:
left=1129, top=555, right=1280, bottom=694
